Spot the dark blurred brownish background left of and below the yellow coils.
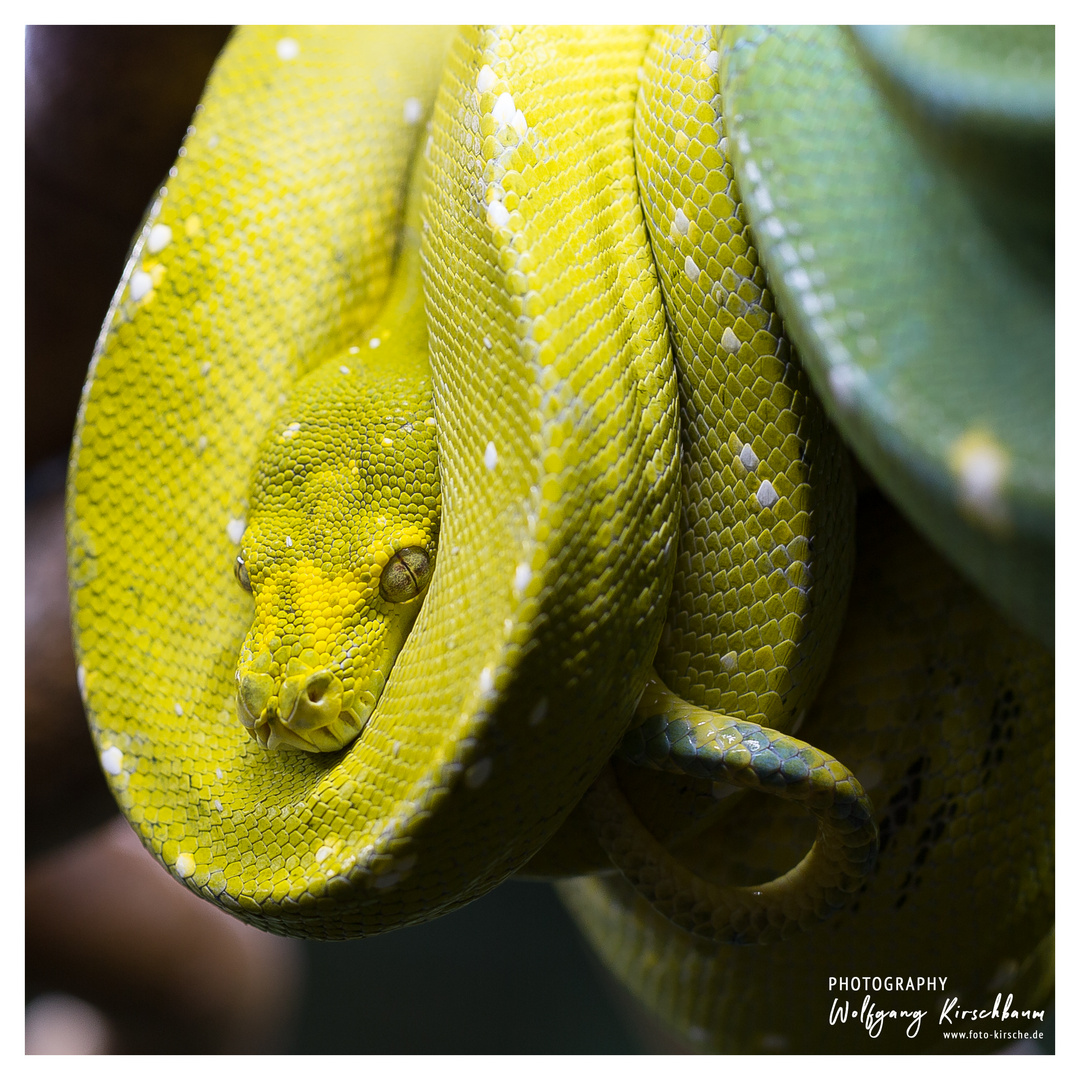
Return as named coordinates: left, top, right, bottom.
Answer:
left=26, top=26, right=656, bottom=1054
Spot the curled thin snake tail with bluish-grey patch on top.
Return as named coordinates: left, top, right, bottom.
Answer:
left=584, top=679, right=878, bottom=945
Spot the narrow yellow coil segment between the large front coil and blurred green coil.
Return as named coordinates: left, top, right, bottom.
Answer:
left=634, top=27, right=854, bottom=730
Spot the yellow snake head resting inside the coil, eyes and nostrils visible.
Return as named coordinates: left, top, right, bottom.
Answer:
left=235, top=358, right=438, bottom=752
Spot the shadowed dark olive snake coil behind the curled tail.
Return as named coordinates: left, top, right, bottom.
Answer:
left=559, top=496, right=1054, bottom=1053
